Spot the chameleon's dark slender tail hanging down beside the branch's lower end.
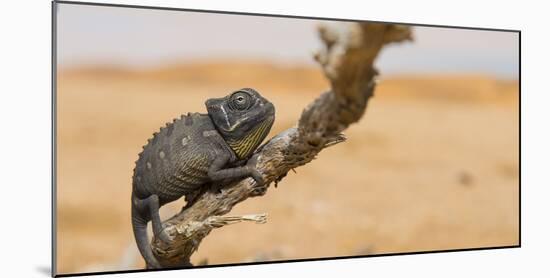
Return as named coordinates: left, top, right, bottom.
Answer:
left=132, top=201, right=161, bottom=268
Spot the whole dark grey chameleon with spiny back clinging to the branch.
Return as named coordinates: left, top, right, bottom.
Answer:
left=131, top=88, right=275, bottom=268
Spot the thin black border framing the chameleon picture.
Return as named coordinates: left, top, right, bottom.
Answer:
left=51, top=0, right=521, bottom=277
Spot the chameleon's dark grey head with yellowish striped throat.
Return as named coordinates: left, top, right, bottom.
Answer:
left=206, top=88, right=275, bottom=159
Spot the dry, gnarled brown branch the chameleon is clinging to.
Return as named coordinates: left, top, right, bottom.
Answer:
left=151, top=23, right=412, bottom=267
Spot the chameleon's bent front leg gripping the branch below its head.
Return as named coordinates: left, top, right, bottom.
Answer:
left=208, top=154, right=264, bottom=185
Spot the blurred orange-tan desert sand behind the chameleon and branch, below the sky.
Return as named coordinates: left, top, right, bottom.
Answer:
left=57, top=60, right=519, bottom=273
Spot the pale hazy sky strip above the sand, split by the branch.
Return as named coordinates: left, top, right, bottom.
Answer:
left=57, top=4, right=519, bottom=78
